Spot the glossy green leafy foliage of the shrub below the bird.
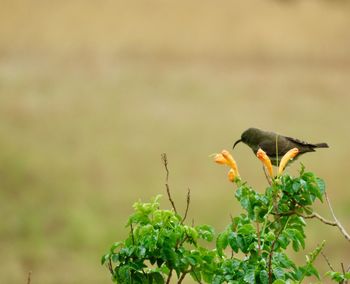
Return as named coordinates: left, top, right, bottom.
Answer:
left=102, top=167, right=349, bottom=284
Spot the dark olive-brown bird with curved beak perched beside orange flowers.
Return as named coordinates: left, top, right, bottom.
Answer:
left=232, top=127, right=329, bottom=166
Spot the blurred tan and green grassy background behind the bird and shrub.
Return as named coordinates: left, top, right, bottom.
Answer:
left=0, top=0, right=350, bottom=284
